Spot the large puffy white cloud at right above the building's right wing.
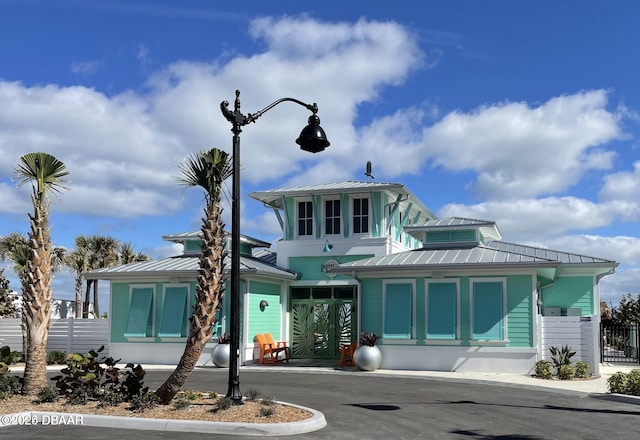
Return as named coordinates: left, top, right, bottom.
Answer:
left=424, top=90, right=624, bottom=199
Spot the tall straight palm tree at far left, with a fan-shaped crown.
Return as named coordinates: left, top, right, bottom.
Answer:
left=15, top=152, right=69, bottom=396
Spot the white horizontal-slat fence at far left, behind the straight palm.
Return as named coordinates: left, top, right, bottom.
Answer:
left=0, top=318, right=109, bottom=356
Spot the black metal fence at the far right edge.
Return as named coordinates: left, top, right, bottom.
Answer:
left=600, top=324, right=640, bottom=364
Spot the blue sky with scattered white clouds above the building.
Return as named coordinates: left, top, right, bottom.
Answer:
left=0, top=0, right=640, bottom=310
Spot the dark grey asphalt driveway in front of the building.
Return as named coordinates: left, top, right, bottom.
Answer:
left=0, top=369, right=640, bottom=440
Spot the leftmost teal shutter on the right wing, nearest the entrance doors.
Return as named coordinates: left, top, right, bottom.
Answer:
left=382, top=284, right=413, bottom=339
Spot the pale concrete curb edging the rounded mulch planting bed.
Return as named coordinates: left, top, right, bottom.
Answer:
left=0, top=402, right=327, bottom=437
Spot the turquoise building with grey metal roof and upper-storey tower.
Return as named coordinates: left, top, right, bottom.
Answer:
left=85, top=181, right=617, bottom=372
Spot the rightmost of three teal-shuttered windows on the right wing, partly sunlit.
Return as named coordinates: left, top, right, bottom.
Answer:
left=471, top=280, right=506, bottom=341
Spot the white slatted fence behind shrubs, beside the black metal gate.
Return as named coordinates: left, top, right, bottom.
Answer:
left=538, top=315, right=600, bottom=374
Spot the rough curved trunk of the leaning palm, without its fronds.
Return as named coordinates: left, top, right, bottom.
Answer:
left=156, top=202, right=225, bottom=405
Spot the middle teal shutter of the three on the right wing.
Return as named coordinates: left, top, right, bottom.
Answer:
left=427, top=283, right=458, bottom=339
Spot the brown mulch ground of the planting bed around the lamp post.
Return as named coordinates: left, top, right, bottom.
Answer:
left=0, top=395, right=313, bottom=423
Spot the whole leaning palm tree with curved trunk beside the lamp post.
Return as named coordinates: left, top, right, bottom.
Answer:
left=156, top=148, right=232, bottom=405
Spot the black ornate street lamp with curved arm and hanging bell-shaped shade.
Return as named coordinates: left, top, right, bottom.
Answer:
left=220, top=90, right=330, bottom=403
